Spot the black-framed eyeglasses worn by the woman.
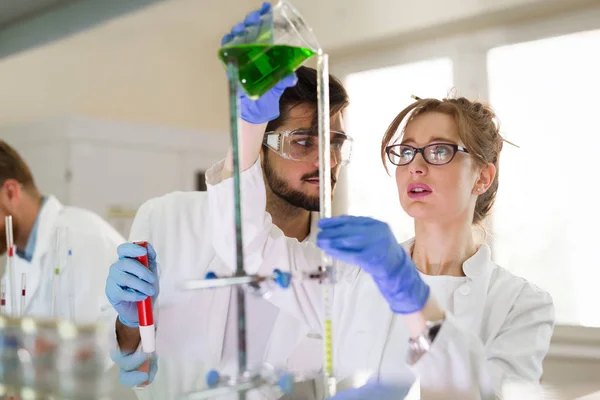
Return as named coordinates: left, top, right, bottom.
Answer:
left=385, top=143, right=469, bottom=166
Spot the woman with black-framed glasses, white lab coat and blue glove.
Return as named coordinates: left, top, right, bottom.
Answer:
left=317, top=98, right=554, bottom=398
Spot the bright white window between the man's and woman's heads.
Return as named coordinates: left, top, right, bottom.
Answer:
left=345, top=58, right=452, bottom=241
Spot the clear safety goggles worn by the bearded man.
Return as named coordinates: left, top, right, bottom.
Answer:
left=263, top=129, right=352, bottom=165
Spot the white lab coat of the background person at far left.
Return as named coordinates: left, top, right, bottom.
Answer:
left=5, top=196, right=124, bottom=324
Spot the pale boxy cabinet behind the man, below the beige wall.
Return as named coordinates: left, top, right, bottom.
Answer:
left=0, top=116, right=228, bottom=237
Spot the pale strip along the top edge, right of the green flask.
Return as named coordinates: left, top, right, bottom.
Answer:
left=308, top=0, right=598, bottom=54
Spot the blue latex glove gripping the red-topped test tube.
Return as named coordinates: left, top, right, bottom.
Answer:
left=105, top=243, right=159, bottom=328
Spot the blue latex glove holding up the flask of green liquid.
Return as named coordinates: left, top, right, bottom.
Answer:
left=221, top=3, right=298, bottom=124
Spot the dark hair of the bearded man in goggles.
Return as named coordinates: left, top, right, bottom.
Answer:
left=267, top=66, right=350, bottom=132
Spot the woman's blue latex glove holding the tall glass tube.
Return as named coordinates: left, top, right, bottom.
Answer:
left=317, top=215, right=429, bottom=314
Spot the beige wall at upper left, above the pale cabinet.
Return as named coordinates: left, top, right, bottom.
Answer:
left=0, top=0, right=254, bottom=132
